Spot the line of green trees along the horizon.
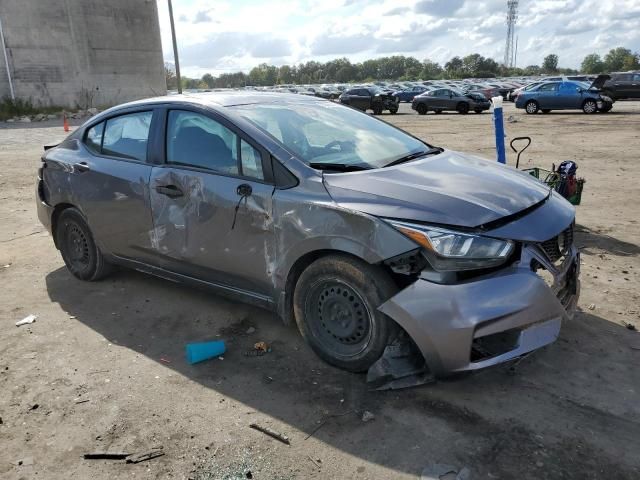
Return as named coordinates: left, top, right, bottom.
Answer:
left=165, top=47, right=640, bottom=90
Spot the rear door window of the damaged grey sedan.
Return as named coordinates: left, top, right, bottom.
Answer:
left=102, top=112, right=153, bottom=162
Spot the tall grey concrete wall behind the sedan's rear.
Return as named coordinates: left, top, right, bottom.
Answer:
left=0, top=0, right=166, bottom=108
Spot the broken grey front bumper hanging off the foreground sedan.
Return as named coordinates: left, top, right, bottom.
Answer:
left=379, top=245, right=580, bottom=377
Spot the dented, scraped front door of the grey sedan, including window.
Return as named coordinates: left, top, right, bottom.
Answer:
left=149, top=110, right=275, bottom=296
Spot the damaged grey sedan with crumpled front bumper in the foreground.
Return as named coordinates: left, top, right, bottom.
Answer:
left=36, top=91, right=580, bottom=376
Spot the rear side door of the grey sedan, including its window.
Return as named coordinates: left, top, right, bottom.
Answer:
left=69, top=108, right=158, bottom=259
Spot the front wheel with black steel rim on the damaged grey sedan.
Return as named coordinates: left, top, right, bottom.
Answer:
left=293, top=255, right=397, bottom=372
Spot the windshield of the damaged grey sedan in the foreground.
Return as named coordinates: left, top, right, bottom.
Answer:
left=230, top=102, right=431, bottom=169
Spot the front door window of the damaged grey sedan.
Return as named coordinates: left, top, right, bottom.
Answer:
left=167, top=110, right=238, bottom=175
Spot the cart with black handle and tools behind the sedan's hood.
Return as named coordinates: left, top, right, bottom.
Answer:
left=509, top=137, right=586, bottom=205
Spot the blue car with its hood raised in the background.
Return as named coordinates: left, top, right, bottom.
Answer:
left=516, top=75, right=613, bottom=113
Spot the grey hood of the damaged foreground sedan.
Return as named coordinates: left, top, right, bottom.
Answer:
left=324, top=150, right=549, bottom=227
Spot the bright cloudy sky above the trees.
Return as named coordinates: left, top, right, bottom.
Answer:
left=157, top=0, right=640, bottom=77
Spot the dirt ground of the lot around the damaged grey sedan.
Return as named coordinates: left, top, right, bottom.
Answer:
left=0, top=102, right=640, bottom=480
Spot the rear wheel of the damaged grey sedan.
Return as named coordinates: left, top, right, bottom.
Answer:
left=56, top=208, right=112, bottom=282
